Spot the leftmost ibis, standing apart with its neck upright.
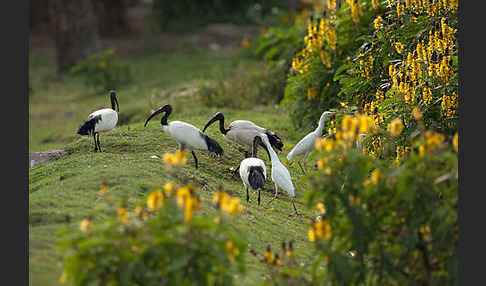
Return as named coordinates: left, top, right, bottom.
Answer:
left=77, top=90, right=120, bottom=152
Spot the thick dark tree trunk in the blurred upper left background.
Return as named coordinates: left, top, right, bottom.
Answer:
left=49, top=0, right=102, bottom=73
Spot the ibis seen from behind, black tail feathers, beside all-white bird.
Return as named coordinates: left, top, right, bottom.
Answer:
left=239, top=135, right=270, bottom=205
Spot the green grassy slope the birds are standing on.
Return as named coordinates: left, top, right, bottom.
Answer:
left=29, top=46, right=314, bottom=285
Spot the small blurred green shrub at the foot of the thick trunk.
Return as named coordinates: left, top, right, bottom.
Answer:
left=70, top=49, right=132, bottom=92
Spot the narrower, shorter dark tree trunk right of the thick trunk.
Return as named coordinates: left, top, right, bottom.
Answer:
left=93, top=0, right=129, bottom=36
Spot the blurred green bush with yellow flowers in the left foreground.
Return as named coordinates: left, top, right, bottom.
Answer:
left=58, top=184, right=246, bottom=285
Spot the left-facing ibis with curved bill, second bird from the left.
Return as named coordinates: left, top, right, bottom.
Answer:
left=144, top=104, right=223, bottom=169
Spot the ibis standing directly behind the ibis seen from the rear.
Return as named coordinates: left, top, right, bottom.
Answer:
left=203, top=112, right=283, bottom=174
